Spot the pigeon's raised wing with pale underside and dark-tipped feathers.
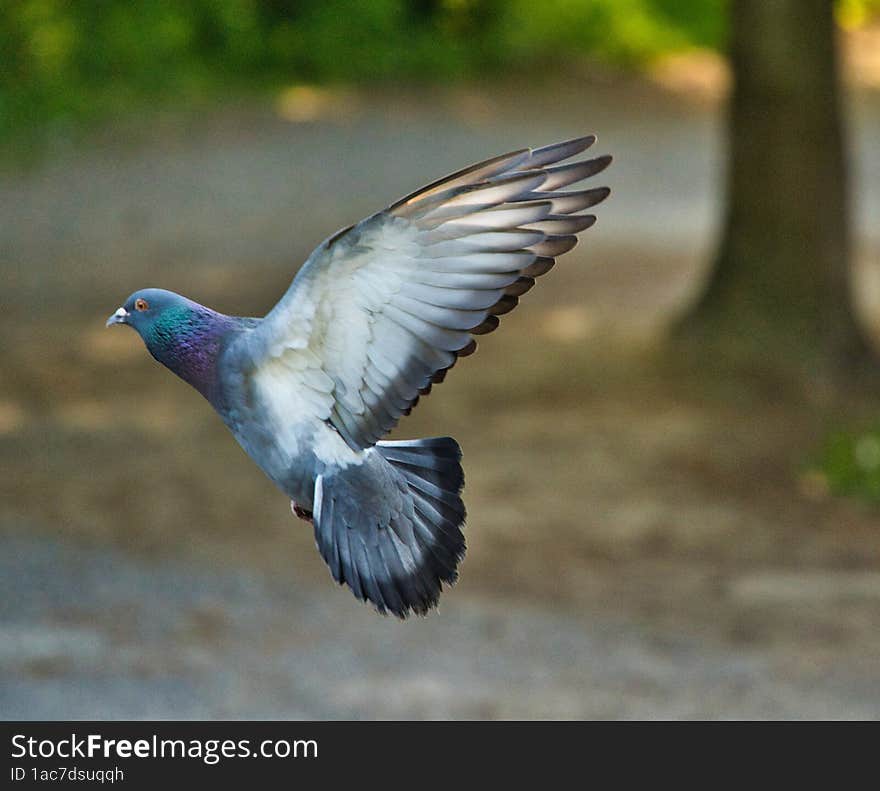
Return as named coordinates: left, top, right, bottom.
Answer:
left=232, top=135, right=611, bottom=449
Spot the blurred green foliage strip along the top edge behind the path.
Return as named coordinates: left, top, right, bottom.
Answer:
left=0, top=0, right=880, bottom=144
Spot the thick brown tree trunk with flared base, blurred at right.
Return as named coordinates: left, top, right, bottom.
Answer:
left=683, top=0, right=870, bottom=369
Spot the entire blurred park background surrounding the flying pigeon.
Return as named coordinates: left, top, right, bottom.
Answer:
left=0, top=0, right=880, bottom=719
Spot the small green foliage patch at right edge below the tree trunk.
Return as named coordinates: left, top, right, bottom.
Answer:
left=814, top=425, right=880, bottom=504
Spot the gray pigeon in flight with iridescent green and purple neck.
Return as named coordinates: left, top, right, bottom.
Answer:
left=107, top=135, right=612, bottom=618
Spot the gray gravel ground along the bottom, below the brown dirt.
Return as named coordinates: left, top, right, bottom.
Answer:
left=0, top=539, right=880, bottom=720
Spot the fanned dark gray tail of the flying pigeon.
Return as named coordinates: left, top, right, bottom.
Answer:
left=314, top=437, right=465, bottom=618
